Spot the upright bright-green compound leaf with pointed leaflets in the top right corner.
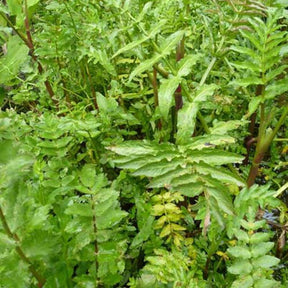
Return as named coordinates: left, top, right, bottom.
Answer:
left=231, top=9, right=288, bottom=114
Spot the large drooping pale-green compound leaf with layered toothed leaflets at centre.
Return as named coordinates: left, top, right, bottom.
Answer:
left=109, top=135, right=245, bottom=228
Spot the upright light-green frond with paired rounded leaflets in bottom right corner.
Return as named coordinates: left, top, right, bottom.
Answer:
left=227, top=186, right=279, bottom=288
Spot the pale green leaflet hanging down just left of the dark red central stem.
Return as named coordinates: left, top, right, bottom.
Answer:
left=158, top=77, right=181, bottom=120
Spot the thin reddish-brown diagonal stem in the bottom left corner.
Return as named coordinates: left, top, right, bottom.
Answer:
left=0, top=207, right=46, bottom=288
